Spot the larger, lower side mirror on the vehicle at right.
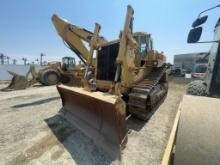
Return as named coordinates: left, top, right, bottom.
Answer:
left=187, top=27, right=202, bottom=43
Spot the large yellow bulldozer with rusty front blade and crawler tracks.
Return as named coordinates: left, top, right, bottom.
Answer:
left=52, top=5, right=168, bottom=156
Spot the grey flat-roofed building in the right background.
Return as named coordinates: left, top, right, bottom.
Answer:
left=173, top=52, right=208, bottom=72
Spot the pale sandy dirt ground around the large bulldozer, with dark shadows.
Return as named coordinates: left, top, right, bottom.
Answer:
left=0, top=80, right=185, bottom=165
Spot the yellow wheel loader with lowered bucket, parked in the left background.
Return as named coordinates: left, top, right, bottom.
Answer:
left=1, top=57, right=84, bottom=91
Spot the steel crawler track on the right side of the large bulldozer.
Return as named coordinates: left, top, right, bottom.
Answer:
left=128, top=66, right=168, bottom=120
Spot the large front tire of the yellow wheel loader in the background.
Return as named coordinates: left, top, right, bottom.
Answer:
left=40, top=69, right=61, bottom=86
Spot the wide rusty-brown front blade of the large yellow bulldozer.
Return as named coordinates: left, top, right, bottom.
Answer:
left=57, top=84, right=127, bottom=158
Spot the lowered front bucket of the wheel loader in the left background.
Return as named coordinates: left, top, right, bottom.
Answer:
left=1, top=71, right=29, bottom=92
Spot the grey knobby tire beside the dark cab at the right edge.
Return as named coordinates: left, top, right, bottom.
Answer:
left=186, top=80, right=207, bottom=96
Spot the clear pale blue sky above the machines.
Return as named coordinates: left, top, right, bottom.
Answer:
left=0, top=0, right=220, bottom=63
